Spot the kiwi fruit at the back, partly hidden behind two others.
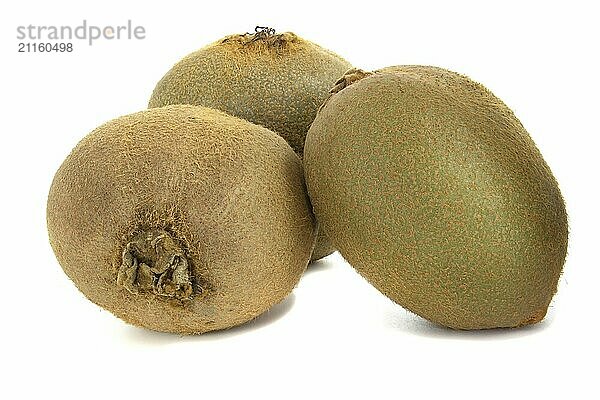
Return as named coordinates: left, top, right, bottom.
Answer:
left=149, top=27, right=351, bottom=260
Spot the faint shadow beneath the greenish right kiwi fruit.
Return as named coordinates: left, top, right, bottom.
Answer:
left=386, top=309, right=553, bottom=340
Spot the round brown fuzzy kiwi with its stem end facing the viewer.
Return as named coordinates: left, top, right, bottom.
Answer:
left=47, top=106, right=316, bottom=334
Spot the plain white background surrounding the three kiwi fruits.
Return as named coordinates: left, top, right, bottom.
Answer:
left=0, top=0, right=600, bottom=399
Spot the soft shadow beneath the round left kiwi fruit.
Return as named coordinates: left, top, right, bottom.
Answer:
left=124, top=293, right=296, bottom=346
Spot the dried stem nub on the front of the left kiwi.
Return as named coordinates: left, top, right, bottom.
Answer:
left=117, top=229, right=194, bottom=300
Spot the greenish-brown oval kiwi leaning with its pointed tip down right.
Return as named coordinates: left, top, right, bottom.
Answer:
left=304, top=66, right=568, bottom=329
